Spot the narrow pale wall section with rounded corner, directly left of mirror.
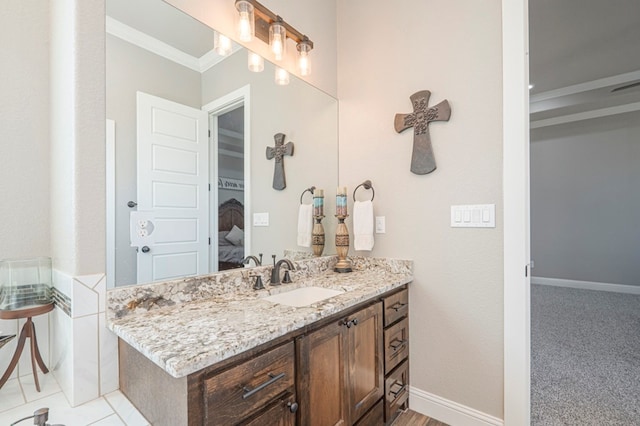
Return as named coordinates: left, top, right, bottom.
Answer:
left=50, top=0, right=105, bottom=276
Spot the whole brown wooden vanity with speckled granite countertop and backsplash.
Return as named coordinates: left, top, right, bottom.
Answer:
left=107, top=256, right=413, bottom=425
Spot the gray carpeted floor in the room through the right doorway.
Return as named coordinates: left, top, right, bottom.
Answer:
left=531, top=285, right=640, bottom=426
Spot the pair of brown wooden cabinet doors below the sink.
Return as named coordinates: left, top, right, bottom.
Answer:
left=296, top=302, right=384, bottom=426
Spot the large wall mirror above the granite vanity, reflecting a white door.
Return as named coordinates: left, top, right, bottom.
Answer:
left=106, top=0, right=338, bottom=286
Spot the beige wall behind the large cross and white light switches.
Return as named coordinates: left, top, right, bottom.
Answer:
left=338, top=0, right=503, bottom=418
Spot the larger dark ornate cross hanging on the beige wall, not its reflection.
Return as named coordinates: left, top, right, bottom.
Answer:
left=394, top=90, right=451, bottom=175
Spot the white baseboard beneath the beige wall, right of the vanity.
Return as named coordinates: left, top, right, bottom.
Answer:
left=409, top=387, right=504, bottom=426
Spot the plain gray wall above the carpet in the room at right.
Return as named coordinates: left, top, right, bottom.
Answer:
left=531, top=112, right=640, bottom=285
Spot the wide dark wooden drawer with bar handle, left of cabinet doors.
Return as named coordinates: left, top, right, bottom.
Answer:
left=204, top=342, right=295, bottom=425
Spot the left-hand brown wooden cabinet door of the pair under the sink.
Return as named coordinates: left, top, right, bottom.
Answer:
left=296, top=321, right=349, bottom=426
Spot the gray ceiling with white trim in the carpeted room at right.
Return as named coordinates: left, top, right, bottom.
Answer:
left=529, top=0, right=640, bottom=127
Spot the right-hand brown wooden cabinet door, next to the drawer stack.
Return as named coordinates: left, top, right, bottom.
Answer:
left=347, top=303, right=384, bottom=422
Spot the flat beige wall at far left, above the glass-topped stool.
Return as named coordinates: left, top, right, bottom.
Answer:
left=0, top=0, right=50, bottom=259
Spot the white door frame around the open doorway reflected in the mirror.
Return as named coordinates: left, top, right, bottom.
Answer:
left=202, top=84, right=251, bottom=269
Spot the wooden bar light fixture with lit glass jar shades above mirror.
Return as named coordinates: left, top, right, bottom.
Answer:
left=236, top=0, right=313, bottom=72
